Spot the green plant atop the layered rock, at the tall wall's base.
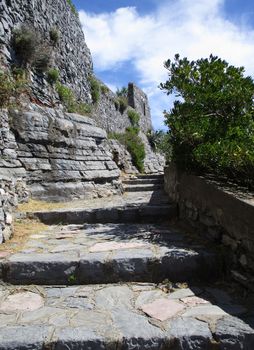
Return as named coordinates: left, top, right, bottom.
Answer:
left=56, top=83, right=92, bottom=115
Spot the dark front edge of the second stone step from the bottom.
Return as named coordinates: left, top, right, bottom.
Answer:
left=0, top=250, right=220, bottom=285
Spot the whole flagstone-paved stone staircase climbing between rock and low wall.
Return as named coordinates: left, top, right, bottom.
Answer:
left=0, top=176, right=254, bottom=350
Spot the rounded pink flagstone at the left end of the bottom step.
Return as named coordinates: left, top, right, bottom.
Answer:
left=0, top=292, right=44, bottom=312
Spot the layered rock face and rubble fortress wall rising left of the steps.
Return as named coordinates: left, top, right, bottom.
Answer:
left=0, top=0, right=164, bottom=242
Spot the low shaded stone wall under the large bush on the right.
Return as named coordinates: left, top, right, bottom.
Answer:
left=165, top=164, right=254, bottom=280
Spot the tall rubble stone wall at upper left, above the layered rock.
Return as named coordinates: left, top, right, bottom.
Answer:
left=0, top=0, right=92, bottom=102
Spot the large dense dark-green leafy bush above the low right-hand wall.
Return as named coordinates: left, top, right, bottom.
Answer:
left=161, top=55, right=254, bottom=186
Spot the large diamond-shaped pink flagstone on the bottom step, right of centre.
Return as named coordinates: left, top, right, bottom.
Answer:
left=141, top=299, right=185, bottom=321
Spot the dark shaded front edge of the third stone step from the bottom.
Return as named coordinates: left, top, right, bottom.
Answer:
left=27, top=204, right=177, bottom=225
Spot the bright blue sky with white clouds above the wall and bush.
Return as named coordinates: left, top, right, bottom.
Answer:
left=73, top=0, right=254, bottom=129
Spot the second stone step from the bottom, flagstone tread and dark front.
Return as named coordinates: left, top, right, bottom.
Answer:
left=0, top=224, right=222, bottom=285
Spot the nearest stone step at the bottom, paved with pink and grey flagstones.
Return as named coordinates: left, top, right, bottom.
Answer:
left=0, top=283, right=254, bottom=350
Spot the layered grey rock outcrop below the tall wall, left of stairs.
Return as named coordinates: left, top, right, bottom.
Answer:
left=0, top=105, right=119, bottom=200
